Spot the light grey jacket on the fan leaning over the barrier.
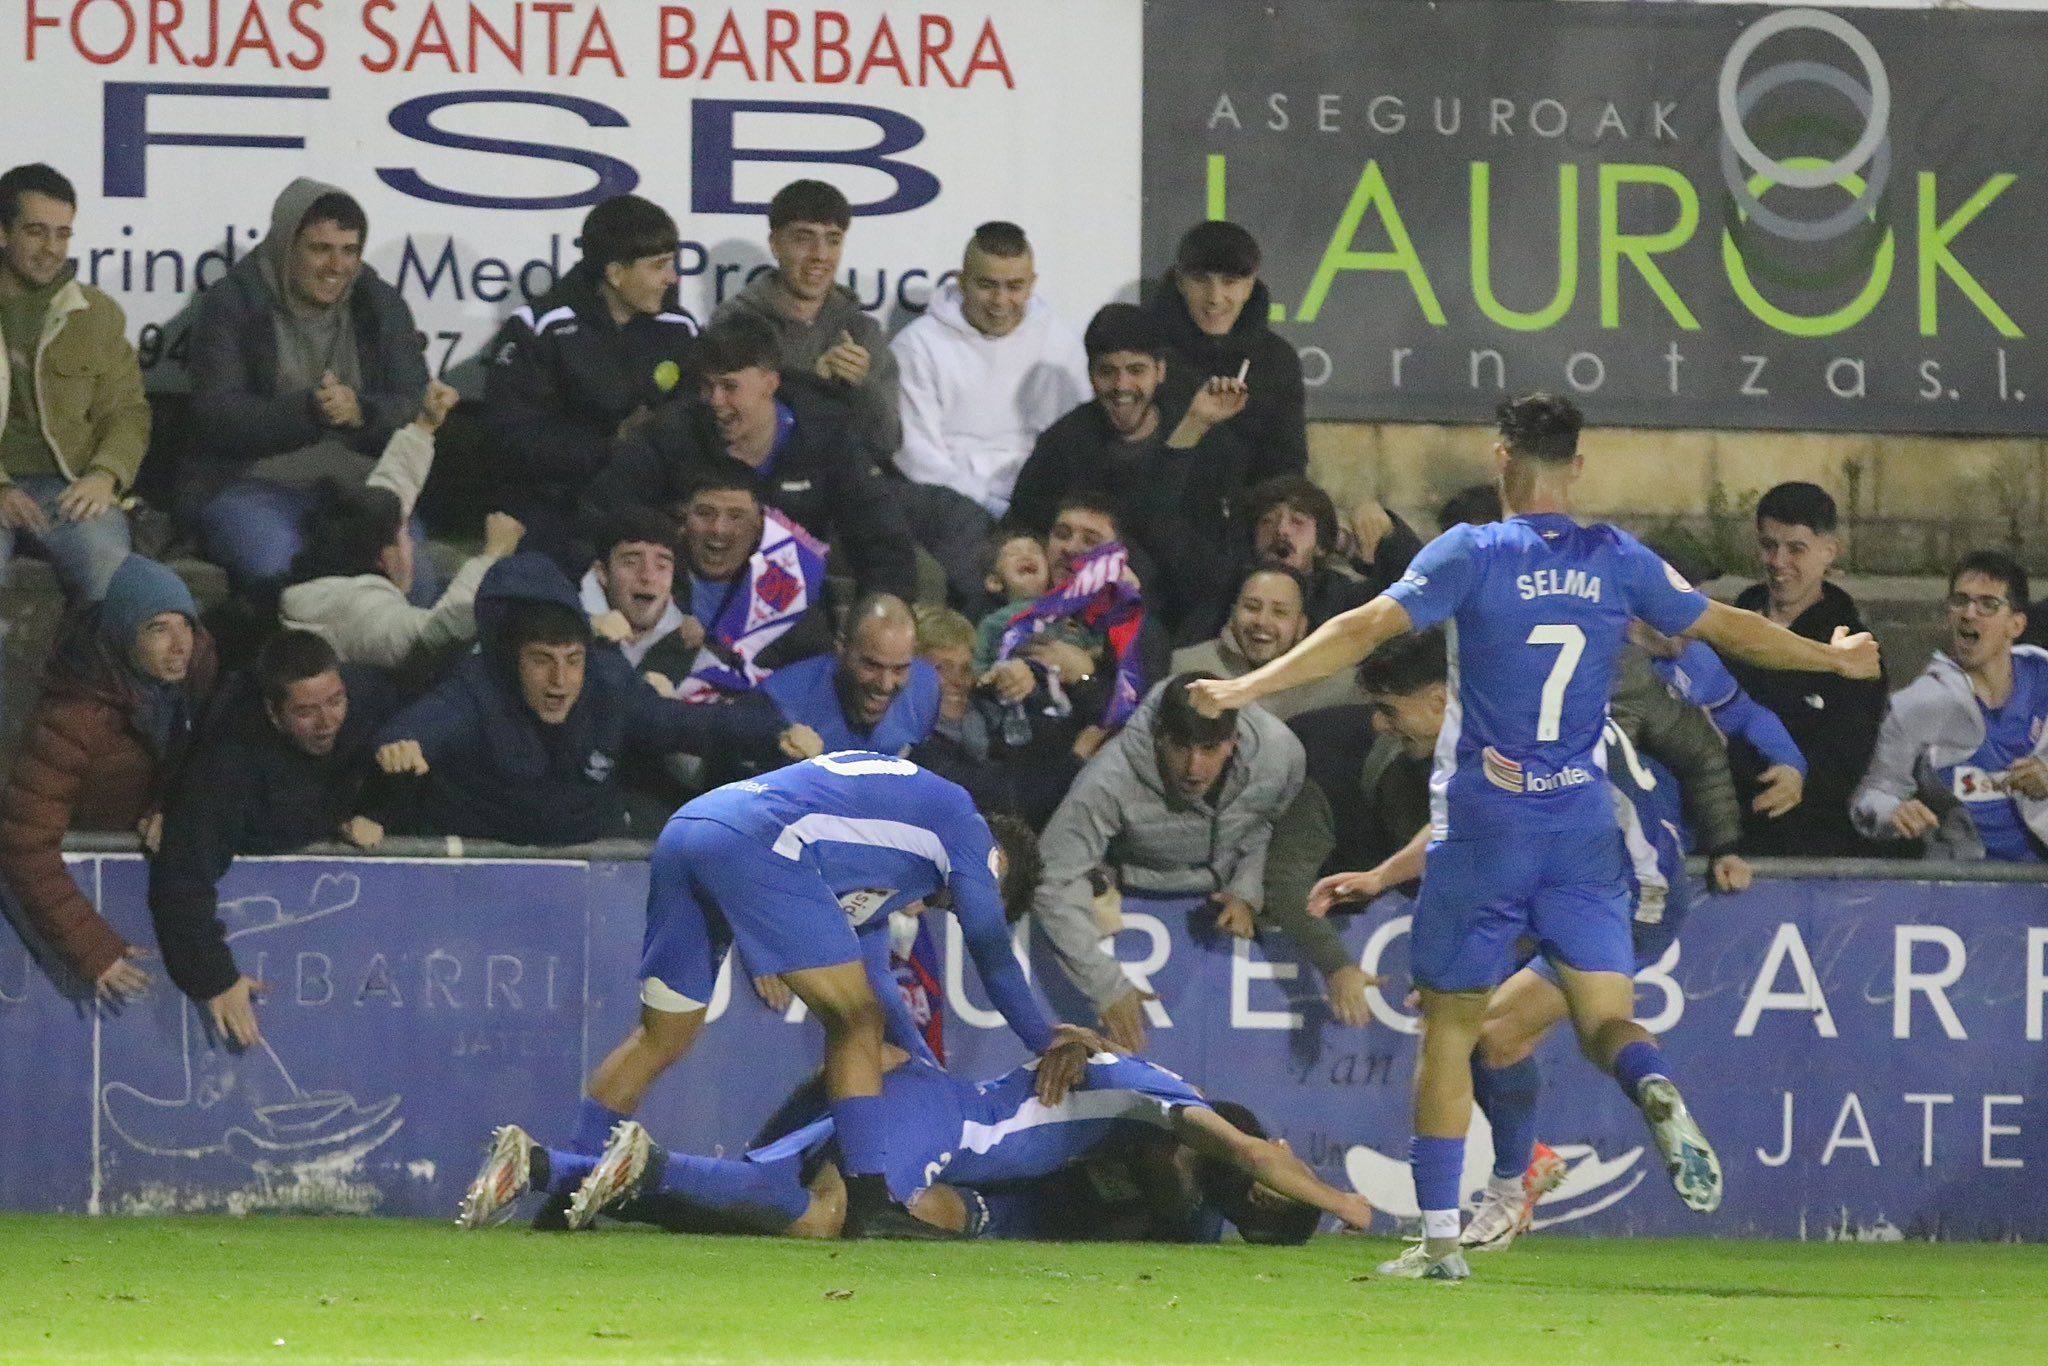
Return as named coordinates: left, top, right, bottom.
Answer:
left=1032, top=684, right=1307, bottom=1008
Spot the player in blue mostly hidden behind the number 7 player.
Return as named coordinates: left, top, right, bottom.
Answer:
left=1309, top=631, right=1751, bottom=1251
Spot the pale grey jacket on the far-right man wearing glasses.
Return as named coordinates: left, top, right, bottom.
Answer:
left=1849, top=645, right=2048, bottom=860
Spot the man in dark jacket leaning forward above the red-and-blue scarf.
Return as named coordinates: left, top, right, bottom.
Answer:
left=584, top=313, right=918, bottom=598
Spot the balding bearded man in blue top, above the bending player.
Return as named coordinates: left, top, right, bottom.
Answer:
left=762, top=594, right=938, bottom=758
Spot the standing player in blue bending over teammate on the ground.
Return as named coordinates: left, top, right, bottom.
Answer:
left=459, top=750, right=1106, bottom=1237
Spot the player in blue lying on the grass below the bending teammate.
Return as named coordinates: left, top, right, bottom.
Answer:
left=456, top=1049, right=1372, bottom=1243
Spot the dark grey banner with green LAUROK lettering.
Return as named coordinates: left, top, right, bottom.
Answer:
left=1145, top=0, right=2048, bottom=434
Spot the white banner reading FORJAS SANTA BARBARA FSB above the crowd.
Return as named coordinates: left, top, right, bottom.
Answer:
left=0, top=0, right=1141, bottom=387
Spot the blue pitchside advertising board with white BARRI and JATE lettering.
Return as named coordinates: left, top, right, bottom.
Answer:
left=0, top=856, right=2048, bottom=1241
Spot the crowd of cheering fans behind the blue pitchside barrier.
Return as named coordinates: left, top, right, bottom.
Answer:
left=0, top=166, right=2048, bottom=1044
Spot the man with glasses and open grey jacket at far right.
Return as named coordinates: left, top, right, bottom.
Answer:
left=1851, top=551, right=2048, bottom=862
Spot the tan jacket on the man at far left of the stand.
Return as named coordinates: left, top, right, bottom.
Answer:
left=0, top=281, right=150, bottom=492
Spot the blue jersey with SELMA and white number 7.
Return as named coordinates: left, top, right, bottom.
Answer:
left=1386, top=514, right=1706, bottom=840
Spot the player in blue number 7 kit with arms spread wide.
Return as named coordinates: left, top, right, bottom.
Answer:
left=1194, top=393, right=1878, bottom=1280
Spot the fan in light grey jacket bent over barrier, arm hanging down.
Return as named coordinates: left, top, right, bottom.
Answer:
left=1032, top=674, right=1307, bottom=1051
